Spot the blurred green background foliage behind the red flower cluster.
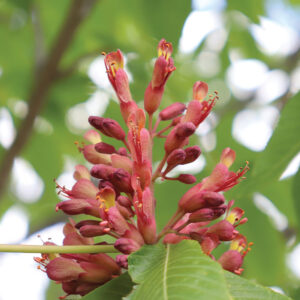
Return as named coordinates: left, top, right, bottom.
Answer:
left=0, top=0, right=300, bottom=299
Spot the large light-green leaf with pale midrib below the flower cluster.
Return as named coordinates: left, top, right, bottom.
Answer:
left=124, top=241, right=289, bottom=300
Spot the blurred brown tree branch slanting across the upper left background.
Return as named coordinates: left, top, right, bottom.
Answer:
left=0, top=0, right=97, bottom=202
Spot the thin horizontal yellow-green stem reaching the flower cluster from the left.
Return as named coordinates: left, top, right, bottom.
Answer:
left=0, top=244, right=119, bottom=253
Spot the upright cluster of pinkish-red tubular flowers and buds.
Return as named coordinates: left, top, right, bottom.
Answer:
left=36, top=39, right=249, bottom=295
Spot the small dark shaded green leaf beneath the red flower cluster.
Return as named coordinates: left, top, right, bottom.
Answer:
left=82, top=272, right=133, bottom=300
